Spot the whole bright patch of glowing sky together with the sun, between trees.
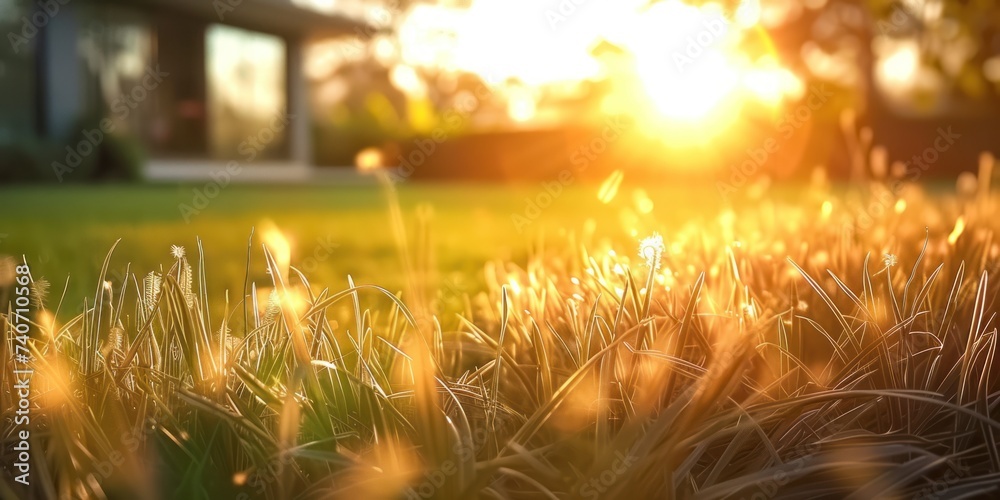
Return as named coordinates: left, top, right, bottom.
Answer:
left=393, top=0, right=803, bottom=142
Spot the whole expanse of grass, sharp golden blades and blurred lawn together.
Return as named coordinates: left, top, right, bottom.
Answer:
left=0, top=173, right=1000, bottom=499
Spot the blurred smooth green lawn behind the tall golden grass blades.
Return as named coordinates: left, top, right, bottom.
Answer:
left=0, top=184, right=719, bottom=318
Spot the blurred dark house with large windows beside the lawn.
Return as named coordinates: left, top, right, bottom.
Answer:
left=0, top=0, right=363, bottom=180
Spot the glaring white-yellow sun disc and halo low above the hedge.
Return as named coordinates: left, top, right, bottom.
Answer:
left=604, top=0, right=802, bottom=145
